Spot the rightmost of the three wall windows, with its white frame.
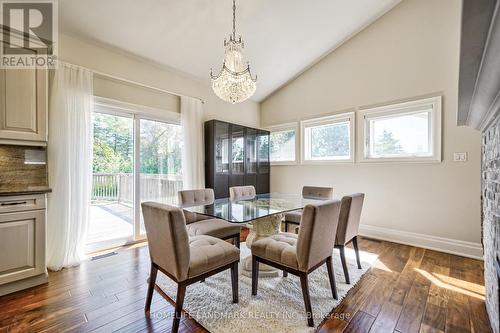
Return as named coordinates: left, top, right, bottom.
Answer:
left=360, top=97, right=441, bottom=161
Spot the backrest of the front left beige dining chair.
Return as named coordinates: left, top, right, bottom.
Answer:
left=141, top=202, right=190, bottom=282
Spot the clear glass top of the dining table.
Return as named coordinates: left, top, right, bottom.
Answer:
left=179, top=193, right=324, bottom=223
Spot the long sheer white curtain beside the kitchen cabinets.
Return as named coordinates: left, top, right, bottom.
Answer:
left=47, top=63, right=93, bottom=270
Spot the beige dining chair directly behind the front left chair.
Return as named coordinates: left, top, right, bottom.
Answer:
left=178, top=188, right=241, bottom=248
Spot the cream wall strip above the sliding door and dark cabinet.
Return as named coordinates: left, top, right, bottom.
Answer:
left=59, top=34, right=260, bottom=127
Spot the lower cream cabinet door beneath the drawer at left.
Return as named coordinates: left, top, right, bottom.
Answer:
left=0, top=210, right=45, bottom=285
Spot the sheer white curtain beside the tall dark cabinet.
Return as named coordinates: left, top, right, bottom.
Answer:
left=181, top=97, right=205, bottom=189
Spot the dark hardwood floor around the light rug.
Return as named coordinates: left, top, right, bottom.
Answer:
left=0, top=235, right=491, bottom=333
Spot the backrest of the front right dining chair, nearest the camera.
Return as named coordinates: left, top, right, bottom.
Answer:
left=297, top=200, right=340, bottom=272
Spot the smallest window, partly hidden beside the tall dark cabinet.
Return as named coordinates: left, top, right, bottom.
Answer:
left=269, top=124, right=298, bottom=165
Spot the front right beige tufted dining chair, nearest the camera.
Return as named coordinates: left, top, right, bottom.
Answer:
left=252, top=200, right=340, bottom=326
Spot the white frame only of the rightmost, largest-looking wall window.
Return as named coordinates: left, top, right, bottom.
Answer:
left=359, top=96, right=442, bottom=163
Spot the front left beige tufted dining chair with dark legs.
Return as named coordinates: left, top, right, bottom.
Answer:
left=141, top=202, right=240, bottom=333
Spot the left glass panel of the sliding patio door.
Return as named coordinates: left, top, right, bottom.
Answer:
left=87, top=112, right=134, bottom=249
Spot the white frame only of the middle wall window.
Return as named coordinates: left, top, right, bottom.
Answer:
left=300, top=111, right=356, bottom=165
